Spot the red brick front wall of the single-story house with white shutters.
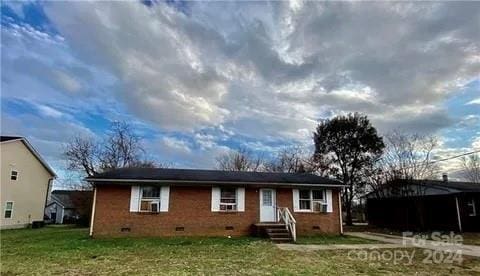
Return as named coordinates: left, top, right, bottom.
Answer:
left=93, top=185, right=340, bottom=236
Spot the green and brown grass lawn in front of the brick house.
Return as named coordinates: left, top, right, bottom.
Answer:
left=1, top=228, right=480, bottom=275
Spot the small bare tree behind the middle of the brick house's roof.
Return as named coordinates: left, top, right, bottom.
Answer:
left=216, top=148, right=264, bottom=172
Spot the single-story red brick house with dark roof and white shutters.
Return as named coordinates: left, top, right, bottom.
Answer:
left=86, top=168, right=343, bottom=239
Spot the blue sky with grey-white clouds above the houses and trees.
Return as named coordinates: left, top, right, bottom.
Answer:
left=1, top=1, right=480, bottom=188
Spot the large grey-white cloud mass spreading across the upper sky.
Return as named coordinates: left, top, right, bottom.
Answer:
left=39, top=2, right=480, bottom=139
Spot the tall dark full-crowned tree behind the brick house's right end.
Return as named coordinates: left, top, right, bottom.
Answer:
left=313, top=113, right=385, bottom=225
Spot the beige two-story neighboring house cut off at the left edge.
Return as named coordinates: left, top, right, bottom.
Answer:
left=0, top=136, right=56, bottom=229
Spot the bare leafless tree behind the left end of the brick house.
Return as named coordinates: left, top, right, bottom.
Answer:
left=64, top=122, right=159, bottom=183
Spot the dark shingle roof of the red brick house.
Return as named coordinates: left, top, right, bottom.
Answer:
left=86, top=168, right=343, bottom=187
